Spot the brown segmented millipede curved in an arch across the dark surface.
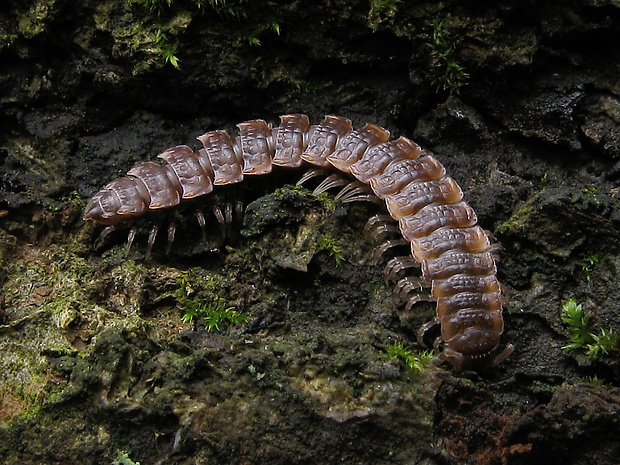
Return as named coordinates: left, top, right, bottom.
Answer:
left=84, top=114, right=513, bottom=370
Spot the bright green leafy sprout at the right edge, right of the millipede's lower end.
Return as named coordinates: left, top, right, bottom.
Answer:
left=562, top=299, right=619, bottom=359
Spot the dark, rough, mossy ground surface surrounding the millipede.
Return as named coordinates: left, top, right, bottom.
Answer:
left=0, top=0, right=620, bottom=465
